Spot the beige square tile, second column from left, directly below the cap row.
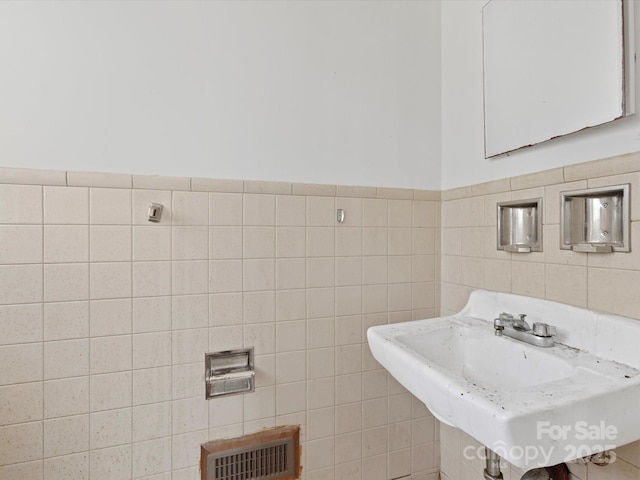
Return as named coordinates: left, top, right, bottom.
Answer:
left=44, top=187, right=89, bottom=225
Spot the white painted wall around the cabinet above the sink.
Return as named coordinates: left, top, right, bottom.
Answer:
left=441, top=0, right=640, bottom=190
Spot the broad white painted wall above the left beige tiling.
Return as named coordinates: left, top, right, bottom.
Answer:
left=0, top=1, right=441, bottom=189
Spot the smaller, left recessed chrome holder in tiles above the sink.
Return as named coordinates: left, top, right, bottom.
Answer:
left=498, top=198, right=542, bottom=253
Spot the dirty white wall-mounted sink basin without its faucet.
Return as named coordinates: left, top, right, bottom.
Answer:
left=367, top=290, right=640, bottom=470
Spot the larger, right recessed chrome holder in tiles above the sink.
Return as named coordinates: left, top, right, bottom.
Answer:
left=560, top=184, right=631, bottom=253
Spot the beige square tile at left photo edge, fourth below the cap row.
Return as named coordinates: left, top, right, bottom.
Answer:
left=0, top=304, right=44, bottom=345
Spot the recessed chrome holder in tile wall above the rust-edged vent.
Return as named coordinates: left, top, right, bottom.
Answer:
left=205, top=347, right=255, bottom=398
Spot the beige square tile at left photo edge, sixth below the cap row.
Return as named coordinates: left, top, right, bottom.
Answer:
left=0, top=382, right=43, bottom=426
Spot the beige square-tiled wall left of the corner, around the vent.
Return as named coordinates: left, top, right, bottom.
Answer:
left=0, top=172, right=439, bottom=480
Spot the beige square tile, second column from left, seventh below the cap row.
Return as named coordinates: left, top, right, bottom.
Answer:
left=44, top=415, right=89, bottom=458
